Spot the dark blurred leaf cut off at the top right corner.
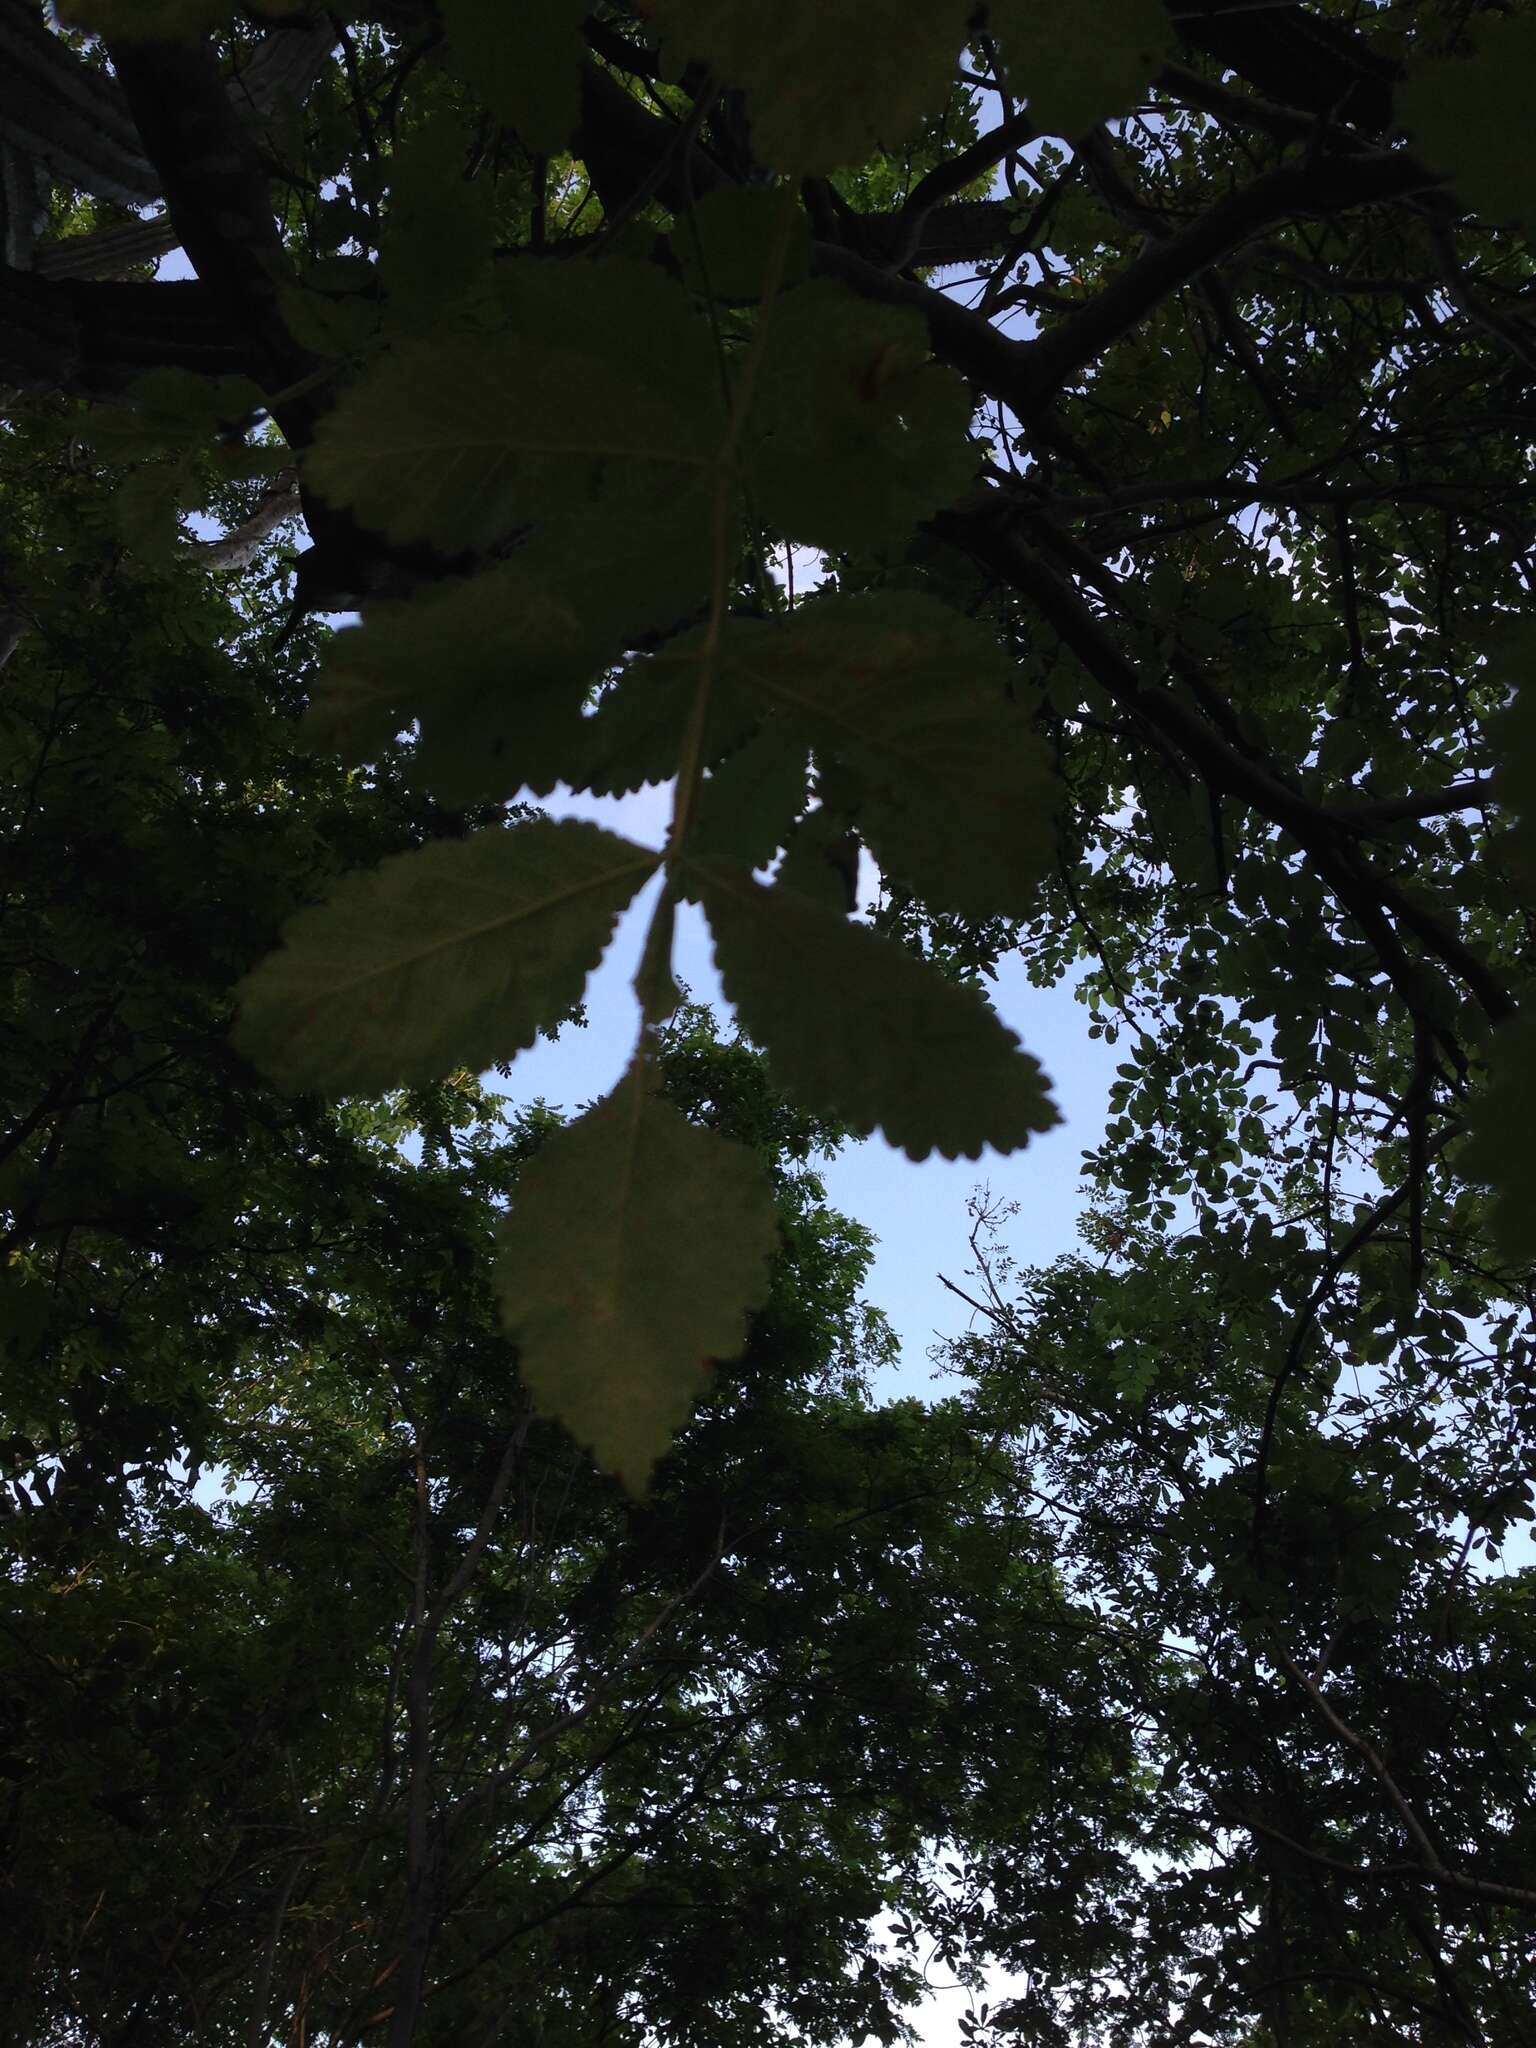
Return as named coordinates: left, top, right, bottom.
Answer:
left=1397, top=14, right=1536, bottom=225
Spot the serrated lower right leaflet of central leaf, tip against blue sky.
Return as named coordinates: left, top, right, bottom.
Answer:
left=684, top=860, right=1059, bottom=1159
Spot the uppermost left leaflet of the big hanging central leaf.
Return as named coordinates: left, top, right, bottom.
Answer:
left=307, top=258, right=723, bottom=555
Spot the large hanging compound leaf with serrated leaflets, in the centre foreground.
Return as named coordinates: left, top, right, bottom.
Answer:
left=238, top=184, right=1055, bottom=1485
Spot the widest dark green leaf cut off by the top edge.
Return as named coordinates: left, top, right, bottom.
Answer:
left=655, top=0, right=971, bottom=176
